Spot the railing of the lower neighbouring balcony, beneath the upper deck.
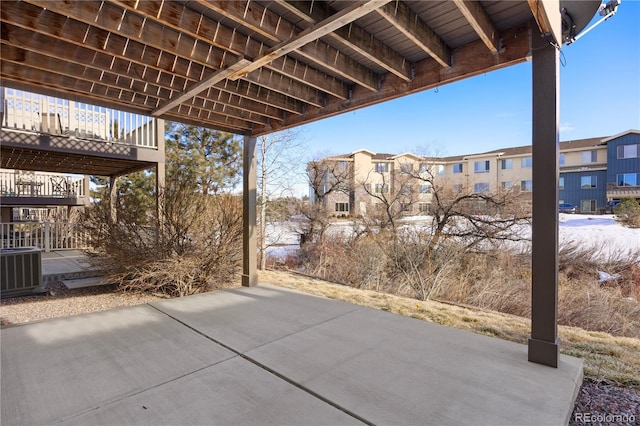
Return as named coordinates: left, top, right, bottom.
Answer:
left=0, top=169, right=88, bottom=198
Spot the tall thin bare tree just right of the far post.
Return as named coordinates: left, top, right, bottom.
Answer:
left=257, top=130, right=305, bottom=269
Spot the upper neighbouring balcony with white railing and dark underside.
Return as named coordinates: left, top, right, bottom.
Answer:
left=0, top=87, right=165, bottom=177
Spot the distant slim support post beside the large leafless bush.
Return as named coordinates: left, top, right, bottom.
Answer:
left=242, top=136, right=258, bottom=287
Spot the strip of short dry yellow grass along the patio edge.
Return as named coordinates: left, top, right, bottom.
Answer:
left=260, top=271, right=640, bottom=388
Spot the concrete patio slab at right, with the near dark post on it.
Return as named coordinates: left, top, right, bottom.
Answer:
left=246, top=302, right=582, bottom=425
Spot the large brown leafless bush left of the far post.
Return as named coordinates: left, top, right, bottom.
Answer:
left=83, top=187, right=242, bottom=296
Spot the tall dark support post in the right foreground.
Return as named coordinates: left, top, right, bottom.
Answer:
left=529, top=27, right=560, bottom=367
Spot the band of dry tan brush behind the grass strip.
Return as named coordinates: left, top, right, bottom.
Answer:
left=296, top=231, right=640, bottom=337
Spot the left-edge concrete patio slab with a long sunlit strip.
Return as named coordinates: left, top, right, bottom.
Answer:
left=0, top=305, right=234, bottom=425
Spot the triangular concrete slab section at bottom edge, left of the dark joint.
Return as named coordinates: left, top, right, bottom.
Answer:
left=62, top=357, right=362, bottom=426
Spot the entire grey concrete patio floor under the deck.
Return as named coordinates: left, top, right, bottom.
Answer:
left=1, top=285, right=582, bottom=425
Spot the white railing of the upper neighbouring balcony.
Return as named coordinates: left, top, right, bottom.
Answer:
left=0, top=87, right=158, bottom=149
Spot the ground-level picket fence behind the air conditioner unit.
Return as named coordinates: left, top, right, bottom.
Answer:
left=0, top=222, right=89, bottom=252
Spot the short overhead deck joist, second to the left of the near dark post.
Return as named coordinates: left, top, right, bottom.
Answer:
left=376, top=1, right=451, bottom=67
